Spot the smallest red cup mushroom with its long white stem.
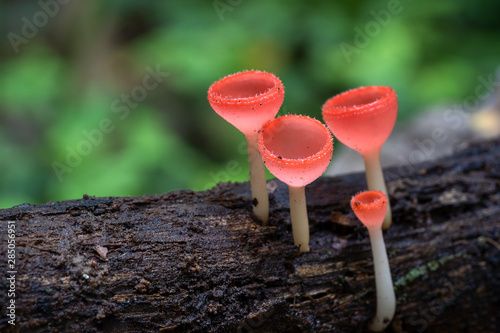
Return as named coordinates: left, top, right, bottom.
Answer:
left=351, top=191, right=396, bottom=332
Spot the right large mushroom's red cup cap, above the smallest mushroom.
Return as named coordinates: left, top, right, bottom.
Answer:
left=323, top=86, right=398, bottom=154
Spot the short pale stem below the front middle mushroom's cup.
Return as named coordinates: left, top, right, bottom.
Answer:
left=288, top=186, right=309, bottom=252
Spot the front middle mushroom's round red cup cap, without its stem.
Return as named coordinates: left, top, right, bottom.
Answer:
left=258, top=115, right=333, bottom=187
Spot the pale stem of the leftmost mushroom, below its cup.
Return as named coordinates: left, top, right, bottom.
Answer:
left=245, top=133, right=269, bottom=225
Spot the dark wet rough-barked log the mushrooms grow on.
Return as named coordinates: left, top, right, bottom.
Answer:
left=0, top=140, right=500, bottom=332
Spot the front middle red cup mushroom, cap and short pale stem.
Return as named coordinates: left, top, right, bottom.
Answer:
left=258, top=115, right=333, bottom=252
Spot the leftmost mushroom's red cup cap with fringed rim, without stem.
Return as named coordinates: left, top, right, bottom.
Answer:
left=208, top=71, right=285, bottom=135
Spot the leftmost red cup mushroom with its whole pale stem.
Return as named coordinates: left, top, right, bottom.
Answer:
left=208, top=70, right=285, bottom=225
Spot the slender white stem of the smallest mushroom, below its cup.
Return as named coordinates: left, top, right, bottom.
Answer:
left=368, top=227, right=396, bottom=332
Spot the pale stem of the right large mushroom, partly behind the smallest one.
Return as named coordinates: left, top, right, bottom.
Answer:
left=363, top=150, right=392, bottom=230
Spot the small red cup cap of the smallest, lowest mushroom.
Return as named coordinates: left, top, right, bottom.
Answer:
left=351, top=191, right=387, bottom=228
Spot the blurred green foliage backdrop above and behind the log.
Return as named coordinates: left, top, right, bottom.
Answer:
left=0, top=0, right=500, bottom=208
